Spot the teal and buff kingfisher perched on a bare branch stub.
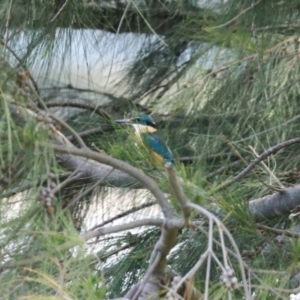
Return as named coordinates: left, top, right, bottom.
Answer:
left=116, top=114, right=174, bottom=167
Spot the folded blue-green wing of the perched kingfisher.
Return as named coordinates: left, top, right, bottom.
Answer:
left=141, top=132, right=174, bottom=163
